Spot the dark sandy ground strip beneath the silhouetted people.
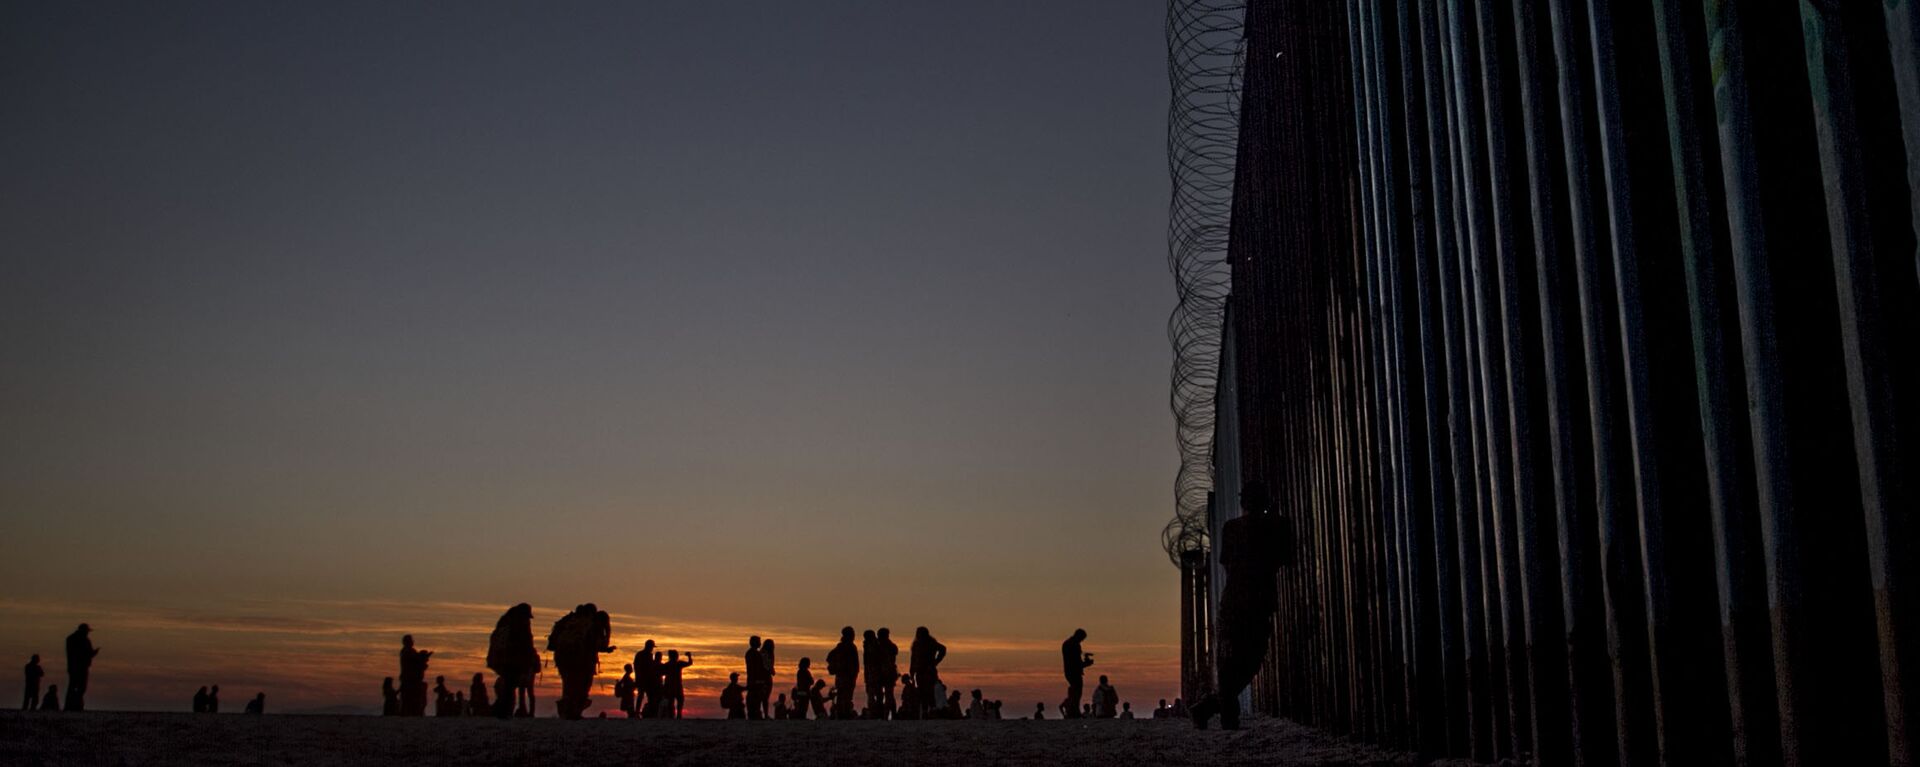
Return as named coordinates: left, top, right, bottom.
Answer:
left=0, top=711, right=1413, bottom=767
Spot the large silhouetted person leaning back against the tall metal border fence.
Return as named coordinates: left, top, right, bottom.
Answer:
left=1192, top=481, right=1292, bottom=730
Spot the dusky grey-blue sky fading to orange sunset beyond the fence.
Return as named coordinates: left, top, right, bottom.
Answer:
left=0, top=0, right=1177, bottom=713
